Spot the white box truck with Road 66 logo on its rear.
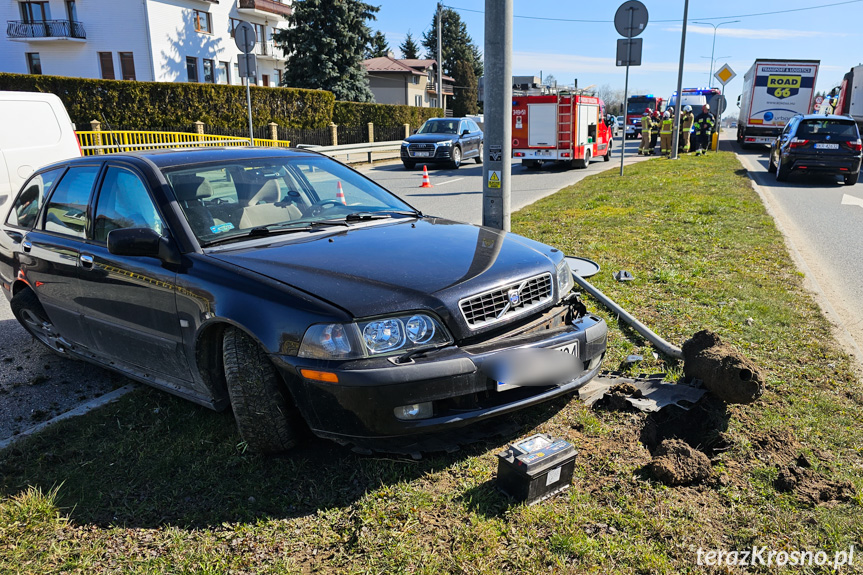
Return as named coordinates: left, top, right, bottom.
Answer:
left=737, top=59, right=821, bottom=147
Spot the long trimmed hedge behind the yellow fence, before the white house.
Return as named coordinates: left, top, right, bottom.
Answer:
left=0, top=73, right=335, bottom=130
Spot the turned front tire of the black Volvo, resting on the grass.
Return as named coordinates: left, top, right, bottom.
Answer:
left=222, top=328, right=299, bottom=454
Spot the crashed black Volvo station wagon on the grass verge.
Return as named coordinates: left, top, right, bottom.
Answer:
left=0, top=148, right=607, bottom=453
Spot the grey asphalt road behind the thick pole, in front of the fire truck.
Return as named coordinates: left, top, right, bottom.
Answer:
left=360, top=138, right=644, bottom=224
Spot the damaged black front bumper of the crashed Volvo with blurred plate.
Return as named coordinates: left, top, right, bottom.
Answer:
left=274, top=309, right=608, bottom=447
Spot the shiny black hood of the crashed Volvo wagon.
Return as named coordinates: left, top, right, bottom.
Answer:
left=209, top=218, right=562, bottom=338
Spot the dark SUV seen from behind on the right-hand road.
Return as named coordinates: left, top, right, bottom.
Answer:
left=767, top=114, right=863, bottom=186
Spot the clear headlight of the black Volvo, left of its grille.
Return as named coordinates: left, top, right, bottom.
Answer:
left=297, top=313, right=452, bottom=360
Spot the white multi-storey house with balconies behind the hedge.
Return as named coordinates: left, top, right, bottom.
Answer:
left=0, top=0, right=291, bottom=86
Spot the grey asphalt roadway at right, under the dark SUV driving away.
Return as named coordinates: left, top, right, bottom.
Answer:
left=732, top=143, right=863, bottom=362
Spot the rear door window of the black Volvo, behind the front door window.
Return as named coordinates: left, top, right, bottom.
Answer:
left=44, top=166, right=99, bottom=238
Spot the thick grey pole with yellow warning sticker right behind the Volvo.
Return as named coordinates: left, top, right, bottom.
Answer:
left=482, top=0, right=512, bottom=232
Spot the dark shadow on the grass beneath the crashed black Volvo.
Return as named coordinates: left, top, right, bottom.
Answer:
left=0, top=388, right=572, bottom=528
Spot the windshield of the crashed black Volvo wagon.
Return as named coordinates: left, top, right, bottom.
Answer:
left=162, top=156, right=421, bottom=245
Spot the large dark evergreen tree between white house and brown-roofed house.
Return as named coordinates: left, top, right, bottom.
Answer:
left=273, top=0, right=378, bottom=102
